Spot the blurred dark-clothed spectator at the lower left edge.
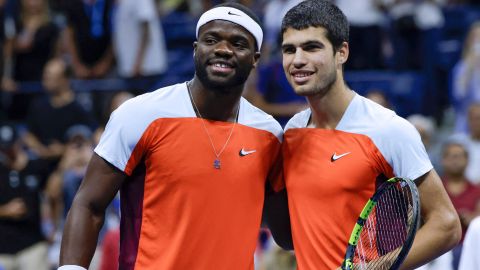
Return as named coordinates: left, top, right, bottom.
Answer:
left=0, top=122, right=49, bottom=270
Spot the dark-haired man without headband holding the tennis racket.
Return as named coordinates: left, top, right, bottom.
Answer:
left=281, top=0, right=461, bottom=270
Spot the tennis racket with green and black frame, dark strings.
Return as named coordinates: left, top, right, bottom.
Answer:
left=341, top=177, right=420, bottom=270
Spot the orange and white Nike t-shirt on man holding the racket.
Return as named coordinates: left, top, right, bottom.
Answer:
left=282, top=95, right=432, bottom=270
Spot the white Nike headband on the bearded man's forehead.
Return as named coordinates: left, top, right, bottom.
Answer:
left=196, top=7, right=263, bottom=51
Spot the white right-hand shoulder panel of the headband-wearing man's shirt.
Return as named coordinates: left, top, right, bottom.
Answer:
left=238, top=97, right=283, bottom=141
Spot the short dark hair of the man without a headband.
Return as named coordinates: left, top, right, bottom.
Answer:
left=281, top=0, right=349, bottom=50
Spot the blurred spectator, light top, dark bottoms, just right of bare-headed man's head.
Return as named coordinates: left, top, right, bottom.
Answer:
left=334, top=0, right=386, bottom=70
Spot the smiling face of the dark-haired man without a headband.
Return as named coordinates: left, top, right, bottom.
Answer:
left=282, top=27, right=348, bottom=96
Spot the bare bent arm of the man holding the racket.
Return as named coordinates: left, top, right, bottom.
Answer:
left=401, top=170, right=462, bottom=269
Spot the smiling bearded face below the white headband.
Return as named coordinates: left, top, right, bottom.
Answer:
left=194, top=20, right=260, bottom=90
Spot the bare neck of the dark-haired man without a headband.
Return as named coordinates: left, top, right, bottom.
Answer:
left=307, top=80, right=355, bottom=129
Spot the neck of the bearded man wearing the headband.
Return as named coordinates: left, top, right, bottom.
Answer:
left=187, top=77, right=243, bottom=122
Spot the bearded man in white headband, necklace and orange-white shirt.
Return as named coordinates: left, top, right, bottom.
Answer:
left=60, top=3, right=283, bottom=270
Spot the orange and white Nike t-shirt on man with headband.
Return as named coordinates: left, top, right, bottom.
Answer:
left=95, top=84, right=282, bottom=270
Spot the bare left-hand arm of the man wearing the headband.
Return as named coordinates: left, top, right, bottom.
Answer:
left=60, top=154, right=126, bottom=268
